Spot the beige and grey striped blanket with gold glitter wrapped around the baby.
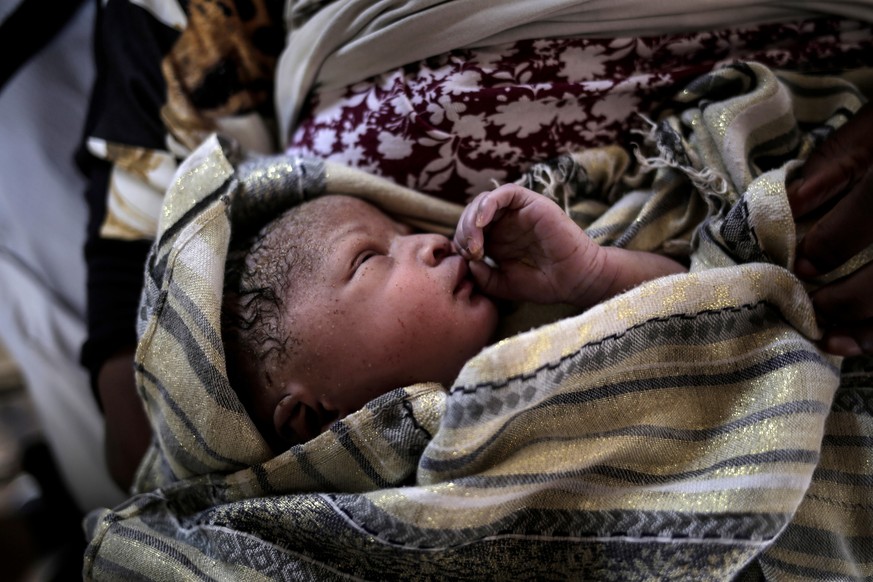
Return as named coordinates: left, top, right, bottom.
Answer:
left=84, top=63, right=873, bottom=580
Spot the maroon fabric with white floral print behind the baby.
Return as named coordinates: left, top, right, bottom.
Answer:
left=288, top=20, right=873, bottom=203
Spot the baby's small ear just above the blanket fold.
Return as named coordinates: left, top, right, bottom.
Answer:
left=273, top=390, right=339, bottom=450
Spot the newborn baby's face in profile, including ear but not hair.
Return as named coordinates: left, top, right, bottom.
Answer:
left=258, top=196, right=497, bottom=443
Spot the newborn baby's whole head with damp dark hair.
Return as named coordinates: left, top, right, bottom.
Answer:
left=222, top=196, right=497, bottom=450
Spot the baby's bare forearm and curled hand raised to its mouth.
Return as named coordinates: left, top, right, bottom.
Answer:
left=455, top=184, right=686, bottom=308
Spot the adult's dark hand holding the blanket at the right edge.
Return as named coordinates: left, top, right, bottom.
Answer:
left=788, top=103, right=873, bottom=356
